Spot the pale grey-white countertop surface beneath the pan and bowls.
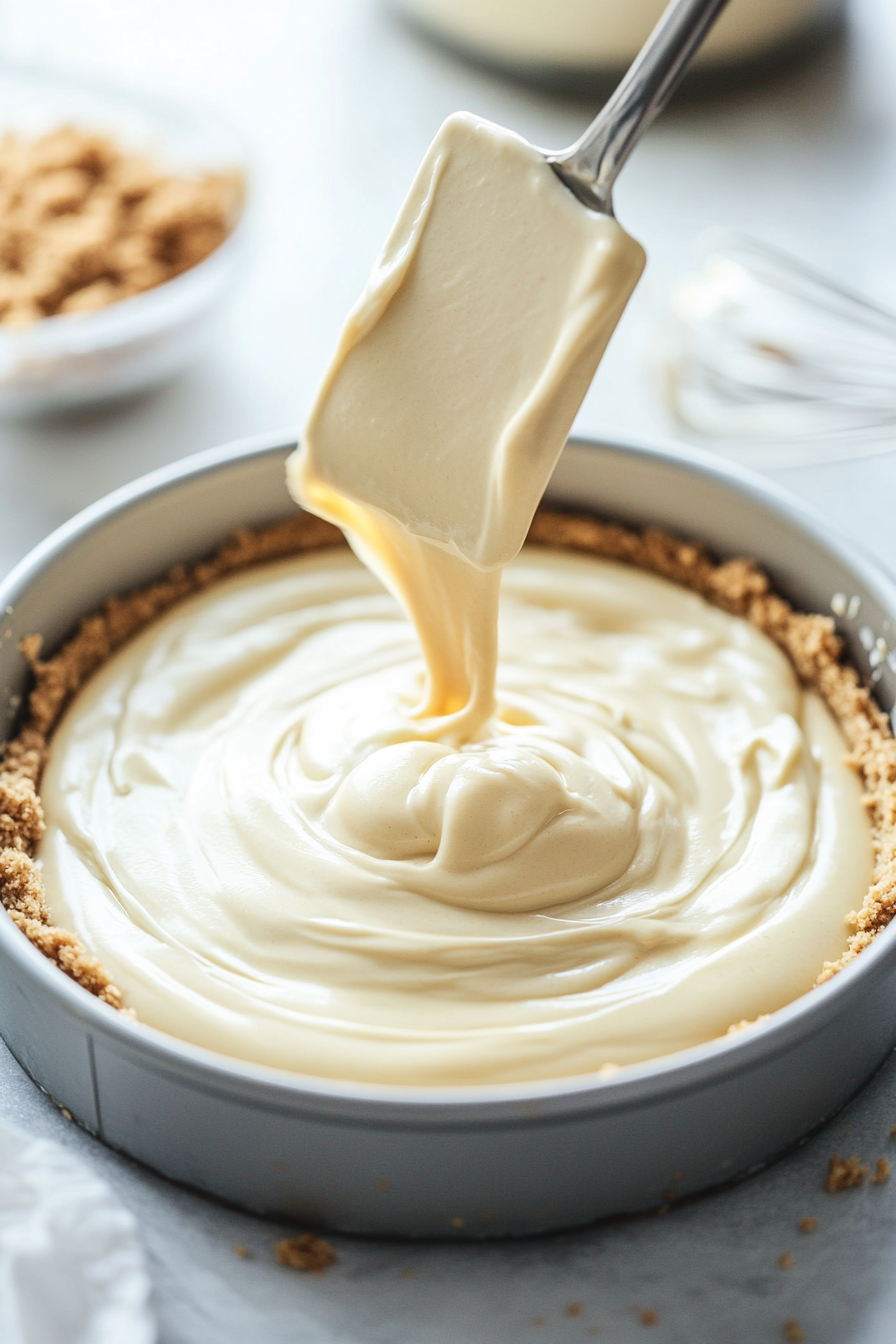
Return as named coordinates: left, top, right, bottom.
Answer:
left=0, top=0, right=896, bottom=1344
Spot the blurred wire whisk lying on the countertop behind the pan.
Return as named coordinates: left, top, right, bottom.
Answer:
left=666, top=233, right=896, bottom=465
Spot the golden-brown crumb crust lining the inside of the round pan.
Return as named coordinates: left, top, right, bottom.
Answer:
left=0, top=508, right=896, bottom=1010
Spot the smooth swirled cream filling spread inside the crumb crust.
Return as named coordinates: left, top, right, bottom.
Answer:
left=42, top=548, right=870, bottom=1085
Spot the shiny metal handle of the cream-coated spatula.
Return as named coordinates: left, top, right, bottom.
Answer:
left=547, top=0, right=728, bottom=215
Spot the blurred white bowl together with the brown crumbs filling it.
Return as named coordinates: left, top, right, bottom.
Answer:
left=0, top=69, right=246, bottom=418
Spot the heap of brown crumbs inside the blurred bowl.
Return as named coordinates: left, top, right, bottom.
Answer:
left=0, top=126, right=243, bottom=328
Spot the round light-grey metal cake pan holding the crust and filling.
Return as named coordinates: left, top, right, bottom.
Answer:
left=0, top=434, right=896, bottom=1238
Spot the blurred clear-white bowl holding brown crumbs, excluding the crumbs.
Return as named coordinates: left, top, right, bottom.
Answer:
left=0, top=66, right=247, bottom=418
